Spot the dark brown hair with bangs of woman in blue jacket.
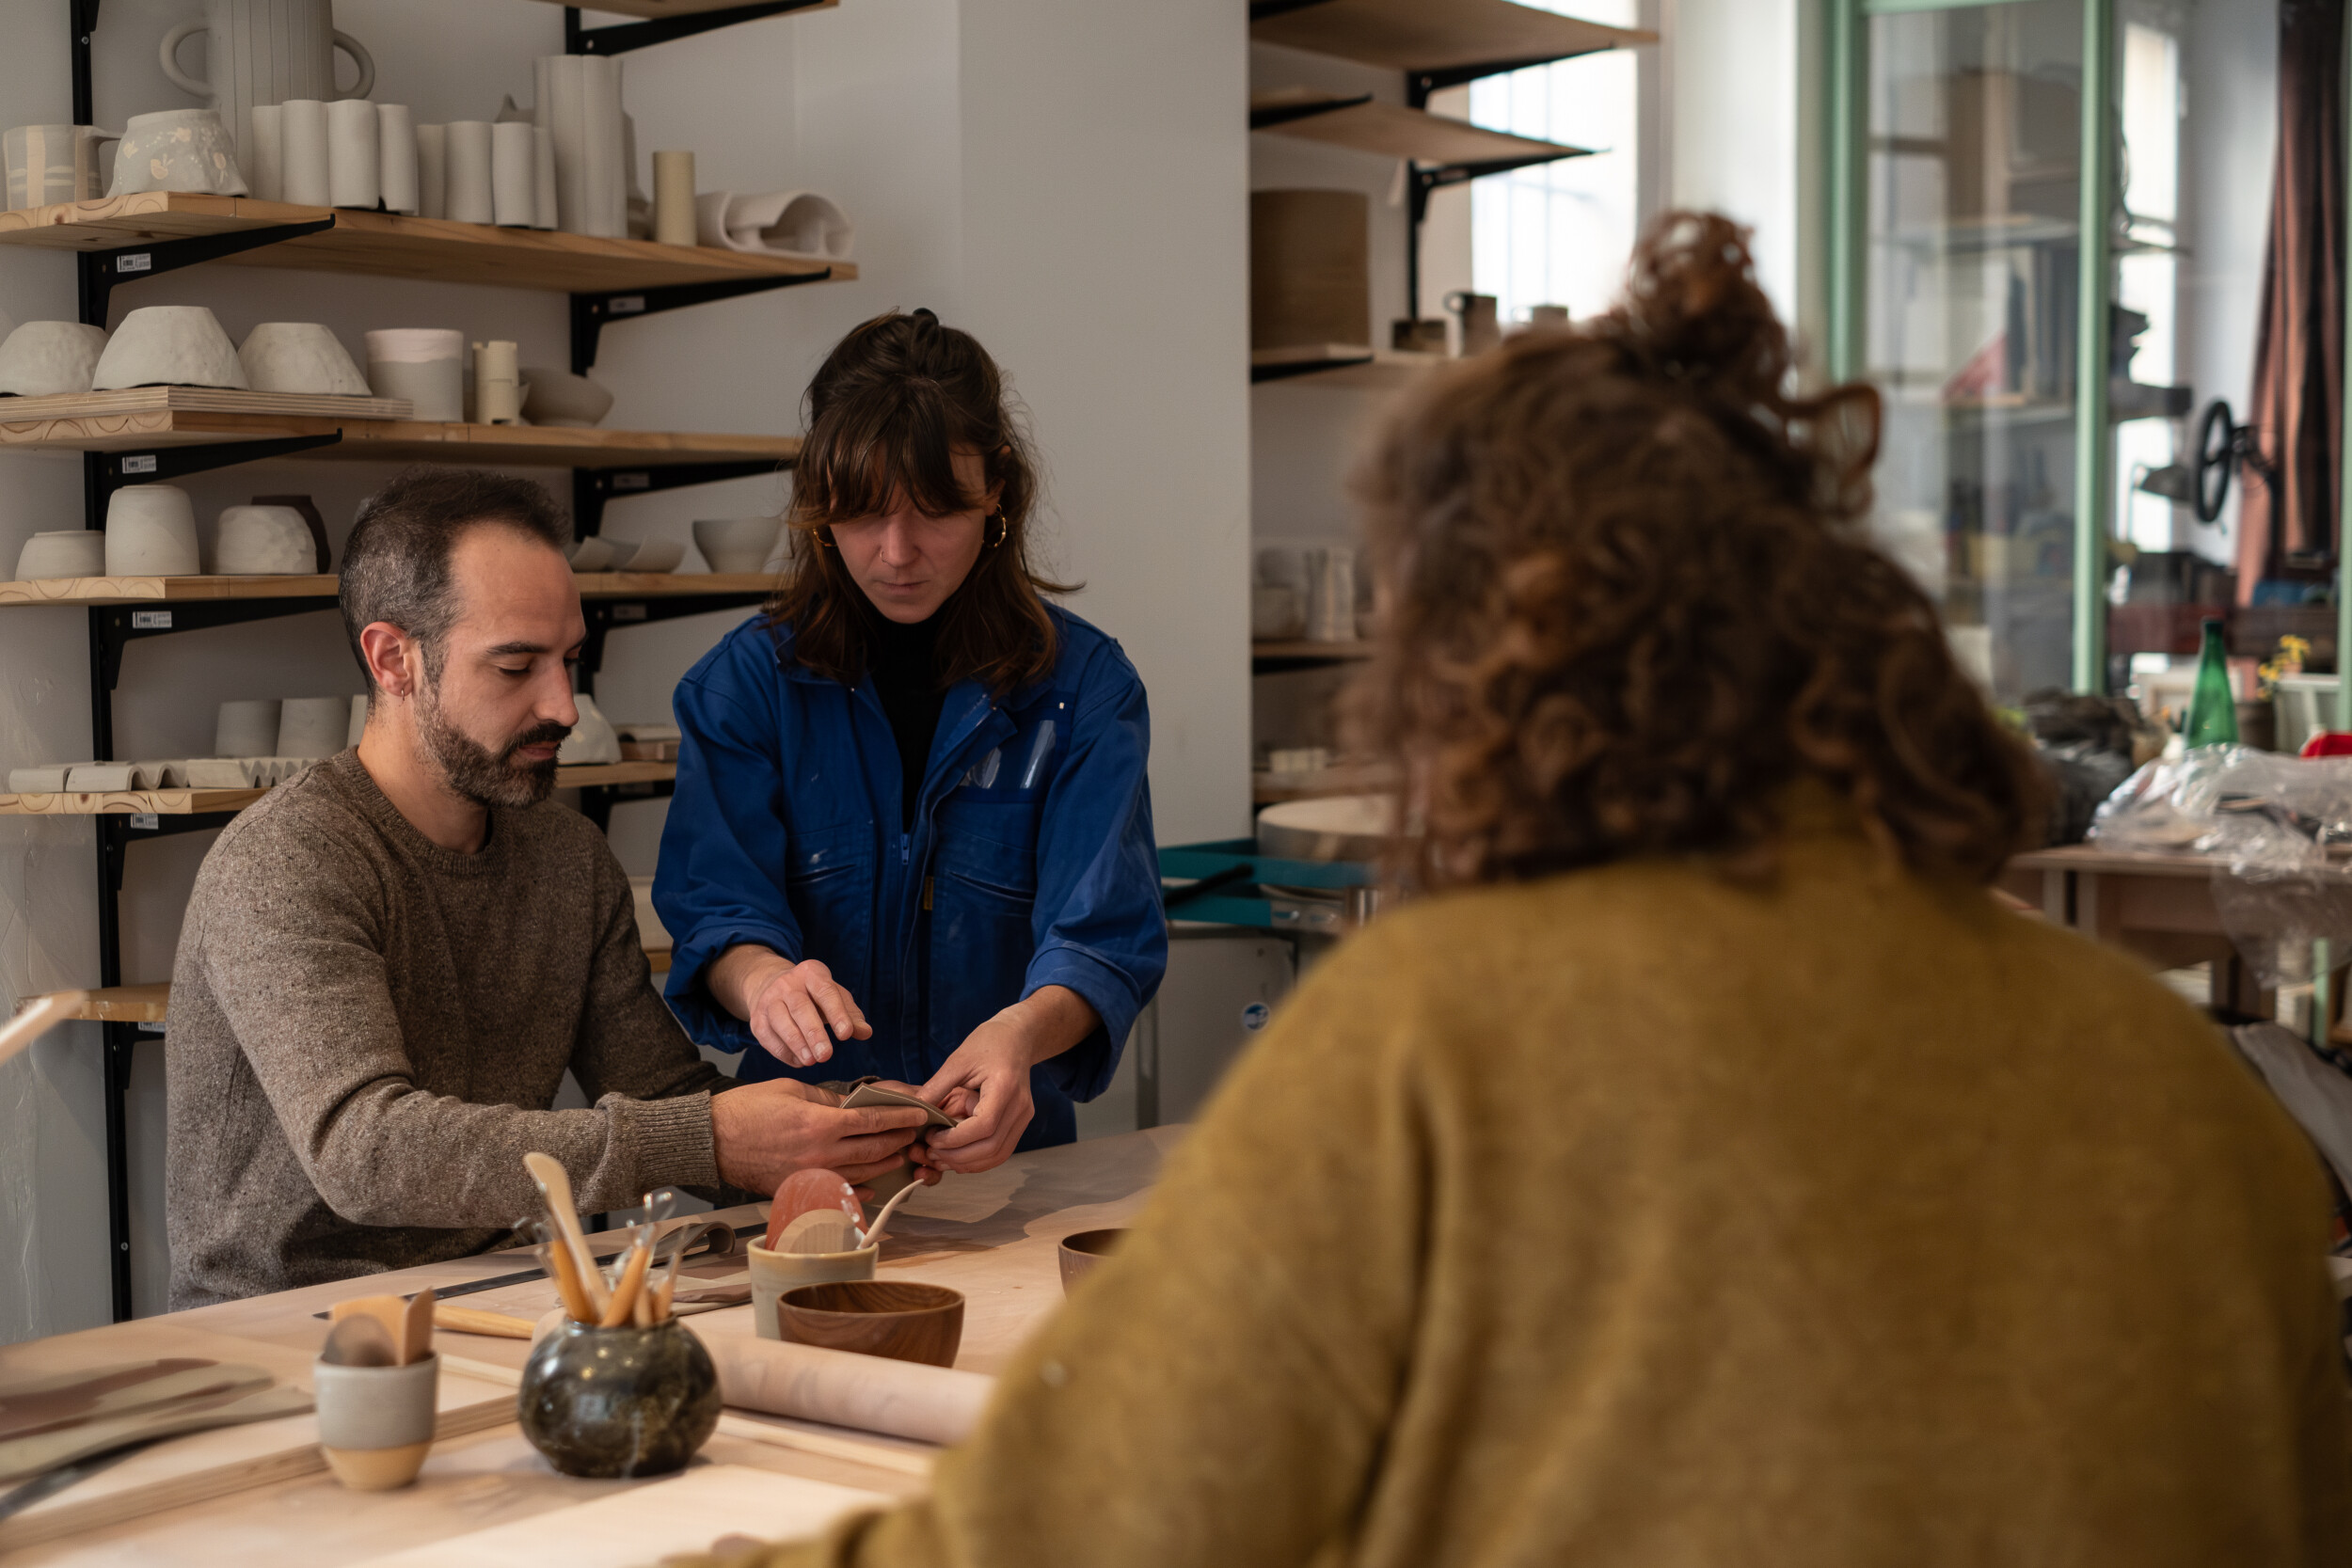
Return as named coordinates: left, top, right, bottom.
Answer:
left=767, top=310, right=1073, bottom=696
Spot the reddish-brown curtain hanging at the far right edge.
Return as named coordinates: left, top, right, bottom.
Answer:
left=2237, top=0, right=2345, bottom=602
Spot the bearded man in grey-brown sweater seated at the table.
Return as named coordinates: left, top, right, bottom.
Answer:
left=165, top=470, right=925, bottom=1309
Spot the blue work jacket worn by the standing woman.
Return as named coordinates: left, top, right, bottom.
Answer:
left=654, top=596, right=1167, bottom=1149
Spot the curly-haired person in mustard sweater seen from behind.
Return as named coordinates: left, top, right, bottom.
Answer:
left=696, top=214, right=2352, bottom=1568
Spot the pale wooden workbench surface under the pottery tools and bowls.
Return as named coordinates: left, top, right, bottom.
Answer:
left=0, top=1129, right=1181, bottom=1568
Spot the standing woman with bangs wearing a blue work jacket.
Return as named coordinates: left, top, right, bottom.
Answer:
left=654, top=310, right=1167, bottom=1171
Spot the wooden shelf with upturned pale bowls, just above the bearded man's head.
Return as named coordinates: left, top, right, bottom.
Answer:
left=0, top=386, right=800, bottom=467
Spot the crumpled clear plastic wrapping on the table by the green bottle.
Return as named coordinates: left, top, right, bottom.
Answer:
left=2091, top=745, right=2352, bottom=988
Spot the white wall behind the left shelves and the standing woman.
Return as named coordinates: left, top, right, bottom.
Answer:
left=0, top=0, right=1249, bottom=1340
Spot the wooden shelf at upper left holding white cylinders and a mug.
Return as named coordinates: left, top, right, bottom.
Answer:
left=0, top=194, right=859, bottom=293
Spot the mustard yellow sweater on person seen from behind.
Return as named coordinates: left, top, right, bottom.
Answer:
left=739, top=830, right=2352, bottom=1568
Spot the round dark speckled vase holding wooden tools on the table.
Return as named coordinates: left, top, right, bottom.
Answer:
left=516, top=1319, right=720, bottom=1481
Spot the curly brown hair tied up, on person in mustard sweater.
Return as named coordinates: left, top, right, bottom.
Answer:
left=1348, top=212, right=2046, bottom=889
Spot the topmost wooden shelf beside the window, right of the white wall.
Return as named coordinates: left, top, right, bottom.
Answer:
left=1249, top=0, right=1659, bottom=71
